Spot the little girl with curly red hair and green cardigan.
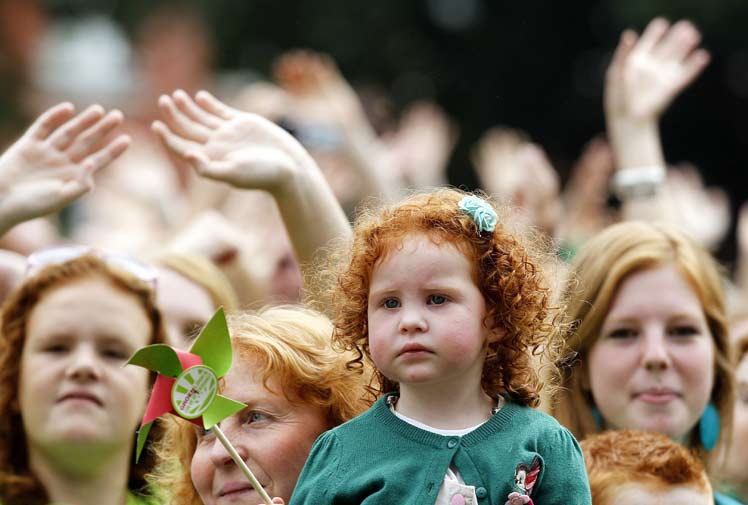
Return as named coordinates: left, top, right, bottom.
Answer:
left=291, top=189, right=591, bottom=505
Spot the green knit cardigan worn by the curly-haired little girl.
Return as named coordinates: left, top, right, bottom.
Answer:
left=290, top=397, right=592, bottom=505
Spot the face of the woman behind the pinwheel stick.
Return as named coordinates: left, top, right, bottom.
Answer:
left=191, top=356, right=329, bottom=505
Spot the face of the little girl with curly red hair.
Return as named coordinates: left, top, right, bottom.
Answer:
left=368, top=235, right=488, bottom=388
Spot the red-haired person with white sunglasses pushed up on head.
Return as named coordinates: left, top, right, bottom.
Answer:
left=0, top=249, right=165, bottom=505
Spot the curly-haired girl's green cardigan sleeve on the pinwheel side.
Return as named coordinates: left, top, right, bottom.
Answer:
left=289, top=431, right=342, bottom=505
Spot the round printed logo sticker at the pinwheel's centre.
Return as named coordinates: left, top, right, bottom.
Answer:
left=171, top=365, right=218, bottom=419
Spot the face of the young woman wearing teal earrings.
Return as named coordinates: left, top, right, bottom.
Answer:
left=588, top=266, right=715, bottom=440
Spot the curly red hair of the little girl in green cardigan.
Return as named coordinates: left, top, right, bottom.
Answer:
left=324, top=189, right=562, bottom=407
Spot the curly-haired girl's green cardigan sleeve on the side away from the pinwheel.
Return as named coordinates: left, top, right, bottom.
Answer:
left=532, top=427, right=592, bottom=505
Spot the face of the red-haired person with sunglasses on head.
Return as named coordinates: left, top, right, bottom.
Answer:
left=18, top=277, right=152, bottom=455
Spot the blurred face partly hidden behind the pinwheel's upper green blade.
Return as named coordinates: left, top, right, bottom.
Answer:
left=156, top=268, right=216, bottom=349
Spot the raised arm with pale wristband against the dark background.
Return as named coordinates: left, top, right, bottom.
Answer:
left=605, top=18, right=709, bottom=217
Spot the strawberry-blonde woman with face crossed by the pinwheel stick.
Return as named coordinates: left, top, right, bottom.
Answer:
left=146, top=306, right=370, bottom=505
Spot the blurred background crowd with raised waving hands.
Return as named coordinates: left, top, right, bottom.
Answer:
left=0, top=1, right=748, bottom=503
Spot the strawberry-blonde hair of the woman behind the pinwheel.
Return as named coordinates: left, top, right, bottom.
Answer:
left=148, top=305, right=371, bottom=505
